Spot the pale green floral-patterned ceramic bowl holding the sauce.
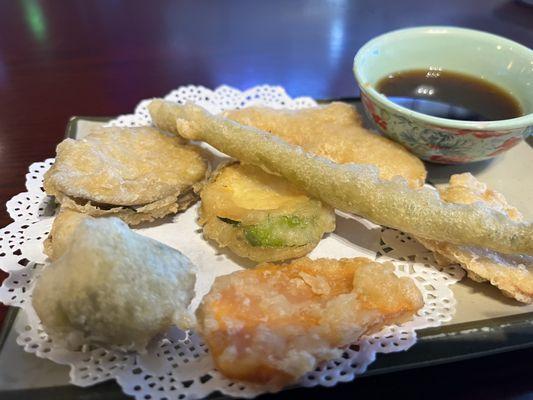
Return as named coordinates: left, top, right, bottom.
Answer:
left=354, top=27, right=533, bottom=164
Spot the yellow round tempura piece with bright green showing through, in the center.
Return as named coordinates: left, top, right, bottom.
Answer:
left=200, top=163, right=335, bottom=262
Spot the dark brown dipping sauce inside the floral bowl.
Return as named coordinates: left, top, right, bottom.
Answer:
left=376, top=69, right=523, bottom=121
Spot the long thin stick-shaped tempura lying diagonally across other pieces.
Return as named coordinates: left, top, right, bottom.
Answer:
left=149, top=100, right=533, bottom=254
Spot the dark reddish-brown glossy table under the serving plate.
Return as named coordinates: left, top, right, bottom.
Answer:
left=0, top=0, right=533, bottom=399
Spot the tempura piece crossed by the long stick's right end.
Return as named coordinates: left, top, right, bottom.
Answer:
left=418, top=173, right=533, bottom=303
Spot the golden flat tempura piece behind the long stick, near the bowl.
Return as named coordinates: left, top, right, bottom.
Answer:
left=224, top=102, right=426, bottom=188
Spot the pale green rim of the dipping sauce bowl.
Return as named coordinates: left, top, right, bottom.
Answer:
left=353, top=25, right=533, bottom=131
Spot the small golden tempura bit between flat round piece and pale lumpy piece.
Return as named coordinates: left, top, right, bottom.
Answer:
left=44, top=208, right=91, bottom=260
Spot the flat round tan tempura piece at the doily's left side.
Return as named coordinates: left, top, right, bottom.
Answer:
left=44, top=127, right=207, bottom=225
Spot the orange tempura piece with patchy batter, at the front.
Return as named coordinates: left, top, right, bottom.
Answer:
left=197, top=258, right=423, bottom=386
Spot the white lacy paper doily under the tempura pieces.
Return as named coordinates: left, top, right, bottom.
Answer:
left=0, top=86, right=464, bottom=400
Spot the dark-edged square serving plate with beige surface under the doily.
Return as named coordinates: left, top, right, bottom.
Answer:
left=0, top=98, right=533, bottom=400
